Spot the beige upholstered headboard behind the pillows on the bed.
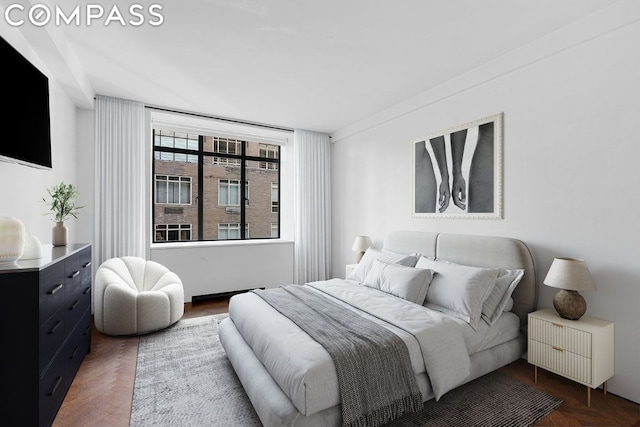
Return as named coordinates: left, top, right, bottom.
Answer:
left=383, top=231, right=538, bottom=325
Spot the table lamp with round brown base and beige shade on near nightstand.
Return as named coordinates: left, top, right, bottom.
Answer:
left=544, top=258, right=596, bottom=320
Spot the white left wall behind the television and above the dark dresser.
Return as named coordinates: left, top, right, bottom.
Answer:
left=0, top=29, right=82, bottom=244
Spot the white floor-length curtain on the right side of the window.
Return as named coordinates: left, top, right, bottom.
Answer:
left=293, top=129, right=331, bottom=284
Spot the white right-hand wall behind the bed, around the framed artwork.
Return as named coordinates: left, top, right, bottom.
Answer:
left=332, top=2, right=640, bottom=402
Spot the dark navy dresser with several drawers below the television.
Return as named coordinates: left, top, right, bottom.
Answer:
left=0, top=244, right=91, bottom=426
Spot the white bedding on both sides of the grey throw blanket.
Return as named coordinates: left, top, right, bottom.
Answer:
left=229, top=279, right=519, bottom=415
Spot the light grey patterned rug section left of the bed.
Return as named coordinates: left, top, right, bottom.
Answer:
left=130, top=316, right=261, bottom=427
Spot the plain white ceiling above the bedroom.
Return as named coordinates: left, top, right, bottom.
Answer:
left=47, top=0, right=612, bottom=133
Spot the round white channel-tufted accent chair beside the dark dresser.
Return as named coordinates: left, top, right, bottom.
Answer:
left=93, top=257, right=184, bottom=336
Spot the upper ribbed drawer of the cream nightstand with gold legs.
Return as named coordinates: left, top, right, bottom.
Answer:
left=529, top=317, right=591, bottom=358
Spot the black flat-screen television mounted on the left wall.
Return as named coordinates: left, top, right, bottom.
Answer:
left=0, top=37, right=51, bottom=169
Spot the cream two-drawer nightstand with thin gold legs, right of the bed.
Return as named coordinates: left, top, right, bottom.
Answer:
left=528, top=309, right=614, bottom=406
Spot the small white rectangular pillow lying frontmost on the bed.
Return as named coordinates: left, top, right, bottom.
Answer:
left=363, top=259, right=433, bottom=305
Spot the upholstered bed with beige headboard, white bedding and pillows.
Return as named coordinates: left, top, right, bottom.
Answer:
left=220, top=231, right=538, bottom=426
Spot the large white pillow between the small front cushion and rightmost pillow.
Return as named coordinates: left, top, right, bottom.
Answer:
left=416, top=257, right=500, bottom=330
